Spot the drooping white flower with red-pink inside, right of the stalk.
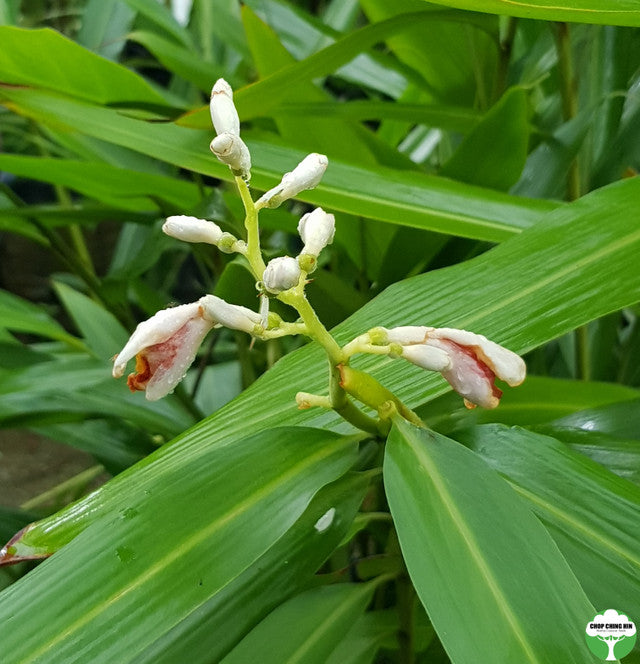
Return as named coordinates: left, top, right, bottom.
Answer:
left=378, top=326, right=527, bottom=408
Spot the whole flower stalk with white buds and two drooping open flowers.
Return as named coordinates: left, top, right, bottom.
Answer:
left=113, top=79, right=526, bottom=435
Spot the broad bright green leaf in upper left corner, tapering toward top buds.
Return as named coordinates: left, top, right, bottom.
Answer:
left=0, top=26, right=171, bottom=106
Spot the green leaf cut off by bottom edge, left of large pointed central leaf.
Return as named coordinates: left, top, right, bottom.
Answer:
left=222, top=582, right=376, bottom=664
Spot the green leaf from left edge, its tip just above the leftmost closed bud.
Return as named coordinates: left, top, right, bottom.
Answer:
left=0, top=154, right=201, bottom=211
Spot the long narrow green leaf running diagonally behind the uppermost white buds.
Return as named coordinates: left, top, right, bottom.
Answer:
left=0, top=87, right=558, bottom=241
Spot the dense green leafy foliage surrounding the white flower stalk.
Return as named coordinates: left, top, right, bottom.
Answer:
left=0, top=0, right=640, bottom=664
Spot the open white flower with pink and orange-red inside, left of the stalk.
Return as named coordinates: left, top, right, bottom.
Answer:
left=113, top=302, right=215, bottom=401
